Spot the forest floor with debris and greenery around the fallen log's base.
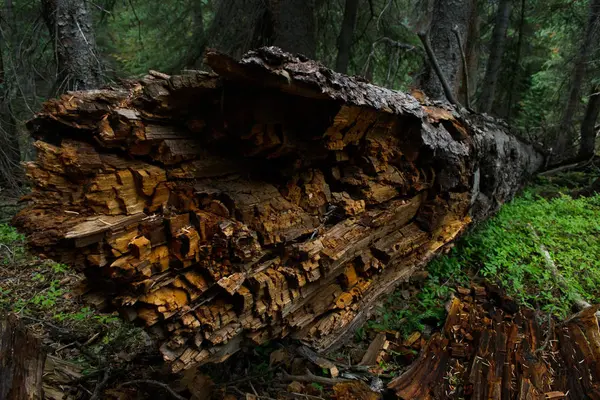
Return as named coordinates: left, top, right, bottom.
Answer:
left=0, top=169, right=600, bottom=400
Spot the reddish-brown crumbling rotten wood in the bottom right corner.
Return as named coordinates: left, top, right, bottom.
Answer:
left=389, top=287, right=600, bottom=400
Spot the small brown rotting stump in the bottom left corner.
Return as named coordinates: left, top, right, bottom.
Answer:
left=0, top=315, right=46, bottom=400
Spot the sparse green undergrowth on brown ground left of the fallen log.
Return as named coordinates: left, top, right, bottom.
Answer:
left=0, top=224, right=147, bottom=365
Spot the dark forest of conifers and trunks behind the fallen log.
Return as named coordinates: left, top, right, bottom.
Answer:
left=0, top=0, right=600, bottom=190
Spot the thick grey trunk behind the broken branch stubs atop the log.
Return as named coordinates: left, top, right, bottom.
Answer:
left=421, top=0, right=473, bottom=99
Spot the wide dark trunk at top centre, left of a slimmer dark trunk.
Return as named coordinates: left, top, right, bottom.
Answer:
left=268, top=0, right=317, bottom=58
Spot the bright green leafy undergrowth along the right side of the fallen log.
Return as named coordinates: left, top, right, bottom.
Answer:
left=368, top=177, right=600, bottom=335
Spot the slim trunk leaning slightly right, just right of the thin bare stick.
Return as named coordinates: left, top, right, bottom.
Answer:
left=479, top=0, right=511, bottom=113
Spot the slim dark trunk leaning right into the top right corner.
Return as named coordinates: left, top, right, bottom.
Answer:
left=553, top=0, right=600, bottom=158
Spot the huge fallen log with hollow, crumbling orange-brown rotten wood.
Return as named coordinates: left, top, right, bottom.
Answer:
left=14, top=48, right=542, bottom=371
